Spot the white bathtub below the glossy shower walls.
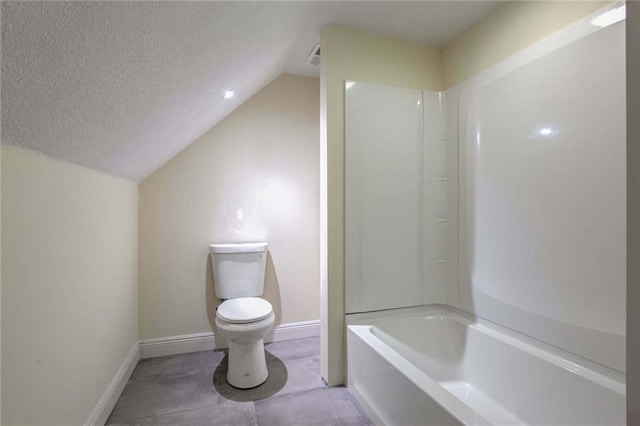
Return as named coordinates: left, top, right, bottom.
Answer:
left=347, top=305, right=626, bottom=426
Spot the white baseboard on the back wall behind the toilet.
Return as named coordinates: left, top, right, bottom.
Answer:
left=140, top=321, right=320, bottom=359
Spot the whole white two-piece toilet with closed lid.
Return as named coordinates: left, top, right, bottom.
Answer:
left=209, top=243, right=275, bottom=389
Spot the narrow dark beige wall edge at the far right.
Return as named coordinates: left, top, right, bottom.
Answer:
left=626, top=2, right=640, bottom=425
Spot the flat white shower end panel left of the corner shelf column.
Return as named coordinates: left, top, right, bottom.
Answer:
left=345, top=82, right=424, bottom=313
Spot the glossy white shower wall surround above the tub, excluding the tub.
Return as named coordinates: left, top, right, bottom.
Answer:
left=345, top=6, right=626, bottom=372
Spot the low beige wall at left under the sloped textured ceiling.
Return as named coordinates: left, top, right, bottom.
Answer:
left=2, top=146, right=138, bottom=425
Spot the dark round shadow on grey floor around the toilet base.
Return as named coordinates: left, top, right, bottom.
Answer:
left=213, top=350, right=288, bottom=402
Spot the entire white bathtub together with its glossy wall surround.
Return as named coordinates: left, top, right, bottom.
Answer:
left=345, top=4, right=626, bottom=425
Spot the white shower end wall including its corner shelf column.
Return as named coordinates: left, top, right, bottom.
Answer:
left=345, top=82, right=450, bottom=313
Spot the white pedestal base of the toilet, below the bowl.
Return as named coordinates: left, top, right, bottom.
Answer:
left=227, top=339, right=269, bottom=389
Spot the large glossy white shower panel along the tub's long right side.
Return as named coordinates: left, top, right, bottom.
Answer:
left=459, top=22, right=626, bottom=371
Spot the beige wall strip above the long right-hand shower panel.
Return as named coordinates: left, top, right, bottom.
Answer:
left=442, top=1, right=609, bottom=88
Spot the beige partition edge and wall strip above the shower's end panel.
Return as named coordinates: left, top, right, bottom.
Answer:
left=320, top=26, right=442, bottom=385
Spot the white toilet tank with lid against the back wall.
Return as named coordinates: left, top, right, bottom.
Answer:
left=209, top=243, right=267, bottom=299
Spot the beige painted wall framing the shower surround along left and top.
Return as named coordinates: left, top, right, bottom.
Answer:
left=320, top=2, right=606, bottom=385
